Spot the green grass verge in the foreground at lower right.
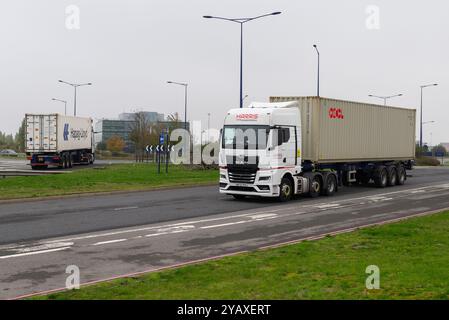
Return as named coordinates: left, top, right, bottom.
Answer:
left=37, top=212, right=449, bottom=299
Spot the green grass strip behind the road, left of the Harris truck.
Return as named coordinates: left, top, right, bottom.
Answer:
left=0, top=164, right=218, bottom=200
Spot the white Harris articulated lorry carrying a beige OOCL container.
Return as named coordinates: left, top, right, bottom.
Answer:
left=219, top=97, right=416, bottom=201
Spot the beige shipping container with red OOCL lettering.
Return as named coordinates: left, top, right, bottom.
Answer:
left=270, top=96, right=416, bottom=163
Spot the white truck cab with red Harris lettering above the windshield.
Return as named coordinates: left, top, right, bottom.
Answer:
left=219, top=102, right=316, bottom=200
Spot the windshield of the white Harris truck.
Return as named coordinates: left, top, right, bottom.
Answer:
left=222, top=125, right=270, bottom=150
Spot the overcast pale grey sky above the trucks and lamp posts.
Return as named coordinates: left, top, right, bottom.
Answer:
left=0, top=0, right=449, bottom=144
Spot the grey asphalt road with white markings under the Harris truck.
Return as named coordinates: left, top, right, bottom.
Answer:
left=0, top=168, right=449, bottom=298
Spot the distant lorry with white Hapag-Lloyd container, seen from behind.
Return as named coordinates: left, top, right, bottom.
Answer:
left=25, top=114, right=95, bottom=169
